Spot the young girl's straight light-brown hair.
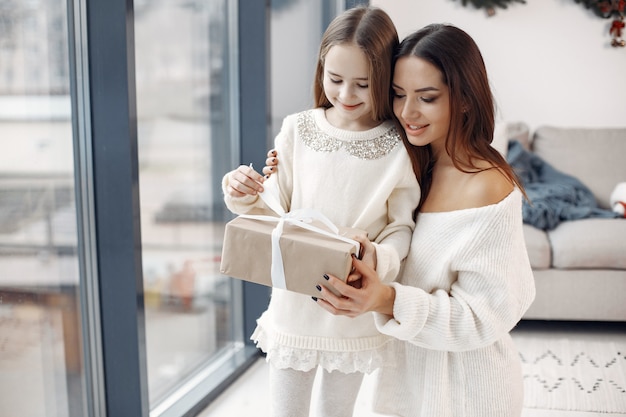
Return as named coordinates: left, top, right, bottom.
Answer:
left=313, top=6, right=399, bottom=121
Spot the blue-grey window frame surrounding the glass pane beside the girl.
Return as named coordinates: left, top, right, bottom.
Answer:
left=72, top=0, right=269, bottom=417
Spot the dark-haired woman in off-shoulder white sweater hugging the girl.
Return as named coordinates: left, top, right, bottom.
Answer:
left=310, top=25, right=535, bottom=417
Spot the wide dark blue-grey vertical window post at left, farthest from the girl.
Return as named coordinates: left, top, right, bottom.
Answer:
left=86, top=0, right=149, bottom=417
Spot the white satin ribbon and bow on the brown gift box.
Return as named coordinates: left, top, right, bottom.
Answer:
left=240, top=181, right=361, bottom=289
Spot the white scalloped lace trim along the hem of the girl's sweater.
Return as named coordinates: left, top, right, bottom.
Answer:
left=250, top=327, right=395, bottom=374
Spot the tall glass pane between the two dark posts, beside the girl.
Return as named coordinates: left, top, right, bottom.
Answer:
left=135, top=0, right=241, bottom=408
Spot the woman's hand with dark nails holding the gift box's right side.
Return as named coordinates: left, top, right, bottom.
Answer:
left=316, top=257, right=396, bottom=317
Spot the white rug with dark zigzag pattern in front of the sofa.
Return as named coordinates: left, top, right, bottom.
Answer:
left=515, top=337, right=626, bottom=413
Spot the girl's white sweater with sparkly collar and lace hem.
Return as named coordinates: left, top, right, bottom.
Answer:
left=223, top=109, right=420, bottom=373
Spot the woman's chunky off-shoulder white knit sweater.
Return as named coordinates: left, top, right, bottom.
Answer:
left=375, top=189, right=535, bottom=417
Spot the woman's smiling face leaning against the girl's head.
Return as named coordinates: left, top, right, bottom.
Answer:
left=393, top=56, right=450, bottom=149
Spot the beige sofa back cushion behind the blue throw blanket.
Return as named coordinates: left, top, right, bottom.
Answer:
left=531, top=126, right=626, bottom=209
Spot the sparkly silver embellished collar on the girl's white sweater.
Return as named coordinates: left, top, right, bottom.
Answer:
left=297, top=112, right=401, bottom=159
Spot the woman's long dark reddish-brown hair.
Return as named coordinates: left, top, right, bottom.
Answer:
left=394, top=24, right=524, bottom=209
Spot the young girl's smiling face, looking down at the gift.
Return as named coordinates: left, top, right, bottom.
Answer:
left=324, top=44, right=373, bottom=130
